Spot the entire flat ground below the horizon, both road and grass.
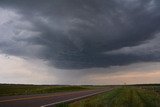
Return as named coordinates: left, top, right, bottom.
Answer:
left=0, top=84, right=160, bottom=107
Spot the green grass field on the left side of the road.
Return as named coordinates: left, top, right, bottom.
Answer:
left=0, top=84, right=93, bottom=96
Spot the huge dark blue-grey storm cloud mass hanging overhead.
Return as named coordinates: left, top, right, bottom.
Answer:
left=0, top=0, right=160, bottom=69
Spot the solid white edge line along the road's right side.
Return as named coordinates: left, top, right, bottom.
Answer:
left=40, top=89, right=112, bottom=107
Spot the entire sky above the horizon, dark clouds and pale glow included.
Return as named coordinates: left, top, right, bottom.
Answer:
left=0, top=0, right=160, bottom=85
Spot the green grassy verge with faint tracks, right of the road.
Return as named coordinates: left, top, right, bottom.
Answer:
left=57, top=87, right=160, bottom=107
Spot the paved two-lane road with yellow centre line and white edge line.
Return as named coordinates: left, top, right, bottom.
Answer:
left=0, top=88, right=112, bottom=107
